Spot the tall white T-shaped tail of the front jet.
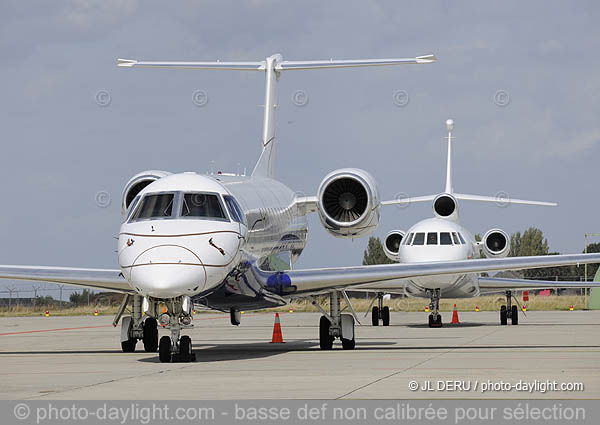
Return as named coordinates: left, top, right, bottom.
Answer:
left=118, top=54, right=437, bottom=177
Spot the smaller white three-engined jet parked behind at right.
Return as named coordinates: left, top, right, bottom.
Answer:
left=367, top=119, right=598, bottom=327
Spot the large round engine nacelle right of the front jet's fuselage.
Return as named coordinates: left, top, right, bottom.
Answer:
left=317, top=168, right=380, bottom=238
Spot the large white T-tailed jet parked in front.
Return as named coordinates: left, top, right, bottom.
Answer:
left=0, top=54, right=600, bottom=362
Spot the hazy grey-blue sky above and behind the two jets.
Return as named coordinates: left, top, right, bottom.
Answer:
left=0, top=0, right=600, bottom=298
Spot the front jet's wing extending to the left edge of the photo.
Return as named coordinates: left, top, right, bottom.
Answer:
left=0, top=265, right=134, bottom=293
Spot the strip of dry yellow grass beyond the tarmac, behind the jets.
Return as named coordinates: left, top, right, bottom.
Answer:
left=0, top=295, right=584, bottom=317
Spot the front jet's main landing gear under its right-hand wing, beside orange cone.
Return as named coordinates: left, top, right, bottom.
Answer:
left=313, top=291, right=356, bottom=350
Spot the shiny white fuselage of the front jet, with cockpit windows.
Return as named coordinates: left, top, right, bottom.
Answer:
left=118, top=173, right=307, bottom=299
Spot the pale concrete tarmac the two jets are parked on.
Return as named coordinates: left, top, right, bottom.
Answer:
left=0, top=311, right=600, bottom=400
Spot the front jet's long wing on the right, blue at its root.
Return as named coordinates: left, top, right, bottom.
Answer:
left=256, top=254, right=600, bottom=296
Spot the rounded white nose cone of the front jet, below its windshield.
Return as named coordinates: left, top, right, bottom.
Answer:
left=131, top=245, right=206, bottom=298
